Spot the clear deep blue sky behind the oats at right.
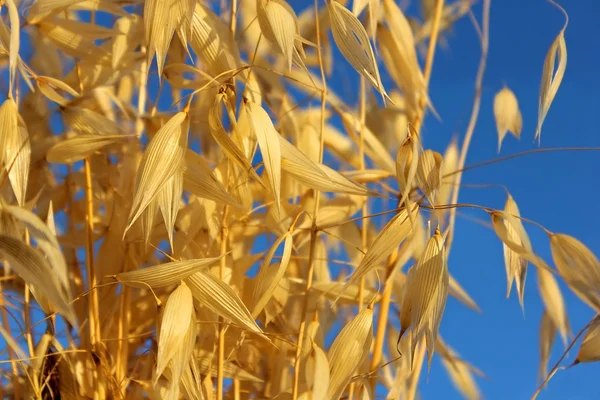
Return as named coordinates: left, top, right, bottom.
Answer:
left=292, top=0, right=600, bottom=400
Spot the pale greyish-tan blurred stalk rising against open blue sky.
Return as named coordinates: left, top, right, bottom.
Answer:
left=446, top=0, right=491, bottom=254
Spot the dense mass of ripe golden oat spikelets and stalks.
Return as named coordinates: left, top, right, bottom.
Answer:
left=0, top=0, right=600, bottom=400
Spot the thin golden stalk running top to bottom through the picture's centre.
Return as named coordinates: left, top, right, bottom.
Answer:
left=292, top=0, right=327, bottom=400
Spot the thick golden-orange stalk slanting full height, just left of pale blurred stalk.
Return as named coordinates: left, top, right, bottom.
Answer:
left=370, top=0, right=444, bottom=392
